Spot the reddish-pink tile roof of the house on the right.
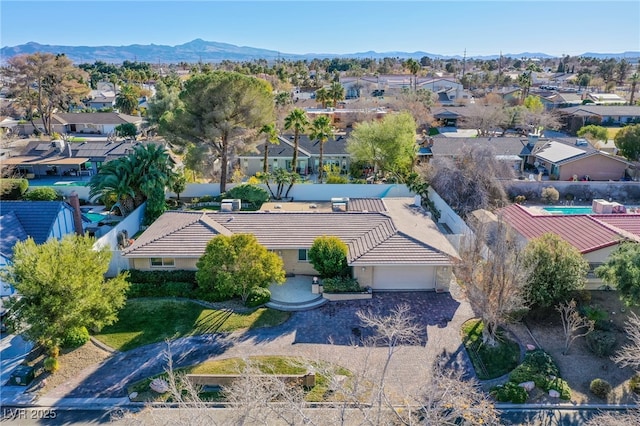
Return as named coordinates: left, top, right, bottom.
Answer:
left=499, top=204, right=625, bottom=253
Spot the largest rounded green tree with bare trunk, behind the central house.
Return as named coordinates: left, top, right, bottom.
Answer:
left=160, top=71, right=275, bottom=192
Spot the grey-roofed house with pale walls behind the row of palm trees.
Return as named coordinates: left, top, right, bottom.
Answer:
left=238, top=133, right=351, bottom=176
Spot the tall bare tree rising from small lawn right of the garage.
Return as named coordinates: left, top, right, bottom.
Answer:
left=454, top=220, right=526, bottom=346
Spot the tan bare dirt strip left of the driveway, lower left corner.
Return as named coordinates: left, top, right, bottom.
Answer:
left=27, top=342, right=111, bottom=395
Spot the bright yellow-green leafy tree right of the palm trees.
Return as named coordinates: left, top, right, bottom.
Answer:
left=347, top=111, right=418, bottom=180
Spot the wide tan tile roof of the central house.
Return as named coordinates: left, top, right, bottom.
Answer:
left=124, top=205, right=451, bottom=264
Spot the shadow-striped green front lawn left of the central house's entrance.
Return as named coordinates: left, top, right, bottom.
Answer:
left=95, top=299, right=289, bottom=351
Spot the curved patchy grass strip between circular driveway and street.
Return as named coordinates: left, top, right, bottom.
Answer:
left=127, top=356, right=351, bottom=402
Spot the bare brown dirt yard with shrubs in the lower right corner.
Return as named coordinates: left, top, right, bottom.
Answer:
left=514, top=291, right=640, bottom=404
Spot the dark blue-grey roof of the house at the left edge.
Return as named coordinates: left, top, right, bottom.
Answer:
left=0, top=200, right=73, bottom=244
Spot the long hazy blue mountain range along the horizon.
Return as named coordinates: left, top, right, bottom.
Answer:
left=0, top=39, right=640, bottom=63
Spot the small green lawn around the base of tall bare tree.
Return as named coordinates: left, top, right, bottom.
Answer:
left=462, top=319, right=520, bottom=380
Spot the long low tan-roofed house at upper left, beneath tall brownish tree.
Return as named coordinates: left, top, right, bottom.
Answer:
left=18, top=112, right=142, bottom=135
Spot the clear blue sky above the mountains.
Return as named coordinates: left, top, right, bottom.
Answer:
left=0, top=0, right=640, bottom=56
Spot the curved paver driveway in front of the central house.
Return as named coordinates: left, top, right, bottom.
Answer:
left=45, top=292, right=472, bottom=398
